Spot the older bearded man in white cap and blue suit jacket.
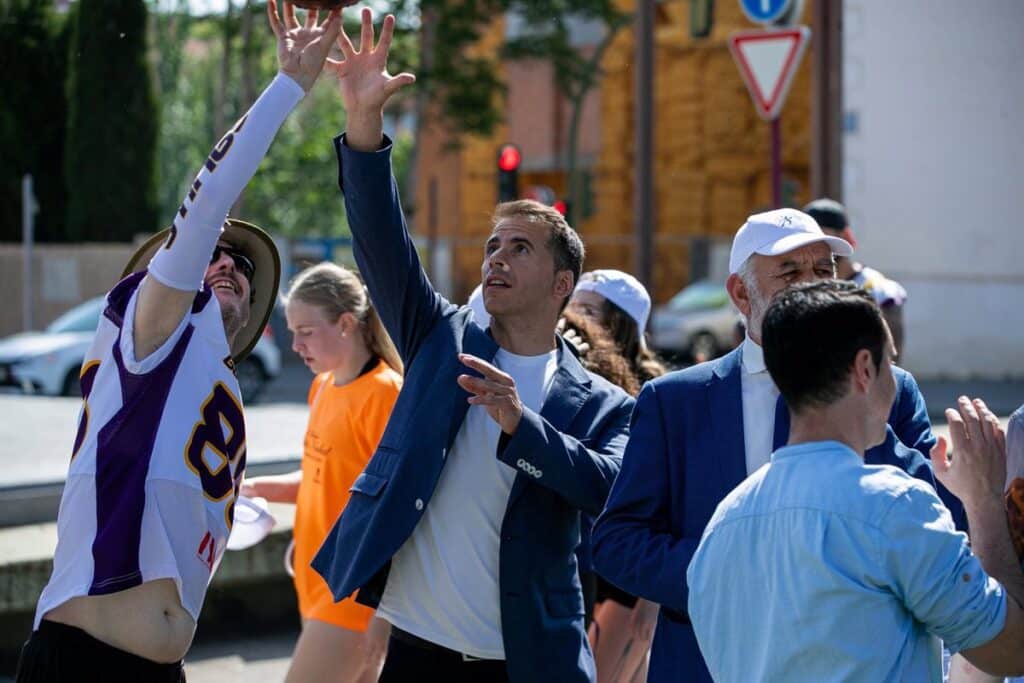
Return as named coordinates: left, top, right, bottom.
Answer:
left=593, top=209, right=950, bottom=683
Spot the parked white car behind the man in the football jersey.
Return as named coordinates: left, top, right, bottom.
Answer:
left=0, top=297, right=281, bottom=401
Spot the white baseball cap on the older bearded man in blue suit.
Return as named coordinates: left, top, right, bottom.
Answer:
left=729, top=209, right=853, bottom=273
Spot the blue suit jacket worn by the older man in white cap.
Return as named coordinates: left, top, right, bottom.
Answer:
left=592, top=349, right=958, bottom=683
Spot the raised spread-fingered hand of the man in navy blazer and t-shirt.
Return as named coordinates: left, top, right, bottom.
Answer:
left=328, top=8, right=416, bottom=118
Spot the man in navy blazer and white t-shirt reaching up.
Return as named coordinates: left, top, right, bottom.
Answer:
left=313, top=10, right=633, bottom=683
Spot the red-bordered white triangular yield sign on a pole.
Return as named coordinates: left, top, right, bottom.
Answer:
left=729, top=27, right=811, bottom=121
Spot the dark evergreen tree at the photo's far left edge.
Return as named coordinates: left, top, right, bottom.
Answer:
left=0, top=0, right=68, bottom=242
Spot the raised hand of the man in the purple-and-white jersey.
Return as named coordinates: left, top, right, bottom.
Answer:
left=266, top=0, right=341, bottom=92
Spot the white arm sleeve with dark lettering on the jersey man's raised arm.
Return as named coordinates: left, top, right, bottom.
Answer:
left=150, top=74, right=305, bottom=291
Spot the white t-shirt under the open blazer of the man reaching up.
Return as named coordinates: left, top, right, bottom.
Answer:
left=377, top=349, right=558, bottom=659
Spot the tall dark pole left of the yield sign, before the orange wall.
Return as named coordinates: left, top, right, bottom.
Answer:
left=633, top=0, right=655, bottom=290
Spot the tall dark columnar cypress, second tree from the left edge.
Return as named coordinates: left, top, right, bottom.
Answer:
left=66, top=0, right=157, bottom=242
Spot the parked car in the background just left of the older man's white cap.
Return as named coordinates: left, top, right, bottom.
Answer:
left=650, top=280, right=739, bottom=359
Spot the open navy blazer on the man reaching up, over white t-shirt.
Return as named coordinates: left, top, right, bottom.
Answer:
left=312, top=137, right=634, bottom=683
